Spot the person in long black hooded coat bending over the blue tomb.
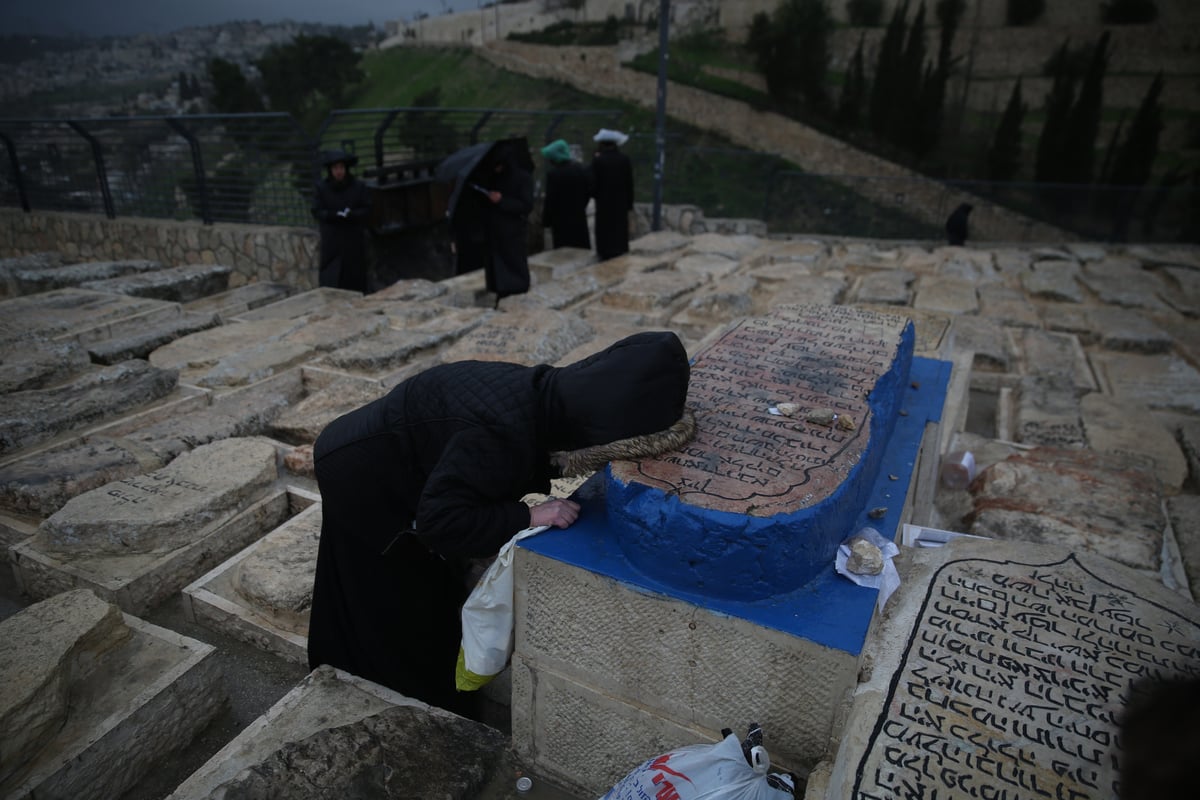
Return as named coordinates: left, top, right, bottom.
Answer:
left=308, top=332, right=694, bottom=715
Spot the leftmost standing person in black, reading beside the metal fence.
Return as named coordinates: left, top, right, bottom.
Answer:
left=312, top=150, right=371, bottom=294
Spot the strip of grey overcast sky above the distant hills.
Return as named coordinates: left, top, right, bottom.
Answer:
left=0, top=0, right=451, bottom=36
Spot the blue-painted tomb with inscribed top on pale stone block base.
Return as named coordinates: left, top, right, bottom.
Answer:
left=511, top=307, right=952, bottom=796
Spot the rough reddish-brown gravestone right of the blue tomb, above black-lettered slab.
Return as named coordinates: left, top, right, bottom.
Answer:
left=965, top=447, right=1166, bottom=575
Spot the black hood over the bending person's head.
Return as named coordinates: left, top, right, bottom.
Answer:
left=544, top=332, right=691, bottom=450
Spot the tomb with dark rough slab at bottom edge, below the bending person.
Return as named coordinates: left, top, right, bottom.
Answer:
left=168, top=667, right=549, bottom=800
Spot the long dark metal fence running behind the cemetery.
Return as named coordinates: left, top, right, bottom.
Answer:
left=0, top=108, right=1200, bottom=242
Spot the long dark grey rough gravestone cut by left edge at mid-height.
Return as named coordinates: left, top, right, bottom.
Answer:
left=0, top=359, right=179, bottom=455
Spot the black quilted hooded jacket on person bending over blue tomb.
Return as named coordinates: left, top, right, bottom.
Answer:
left=314, top=333, right=689, bottom=557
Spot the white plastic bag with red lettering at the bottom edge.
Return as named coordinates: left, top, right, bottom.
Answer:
left=600, top=733, right=794, bottom=800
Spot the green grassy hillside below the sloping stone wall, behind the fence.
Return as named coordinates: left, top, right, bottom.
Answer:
left=343, top=47, right=937, bottom=237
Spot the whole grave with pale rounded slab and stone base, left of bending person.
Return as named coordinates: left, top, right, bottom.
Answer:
left=10, top=438, right=304, bottom=614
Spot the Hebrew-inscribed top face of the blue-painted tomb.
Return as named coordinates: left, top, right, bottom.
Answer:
left=617, top=306, right=907, bottom=517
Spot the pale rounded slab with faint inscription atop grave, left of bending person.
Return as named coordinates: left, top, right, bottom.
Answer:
left=40, top=439, right=278, bottom=555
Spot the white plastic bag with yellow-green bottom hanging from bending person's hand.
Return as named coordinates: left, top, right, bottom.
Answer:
left=455, top=525, right=548, bottom=692
